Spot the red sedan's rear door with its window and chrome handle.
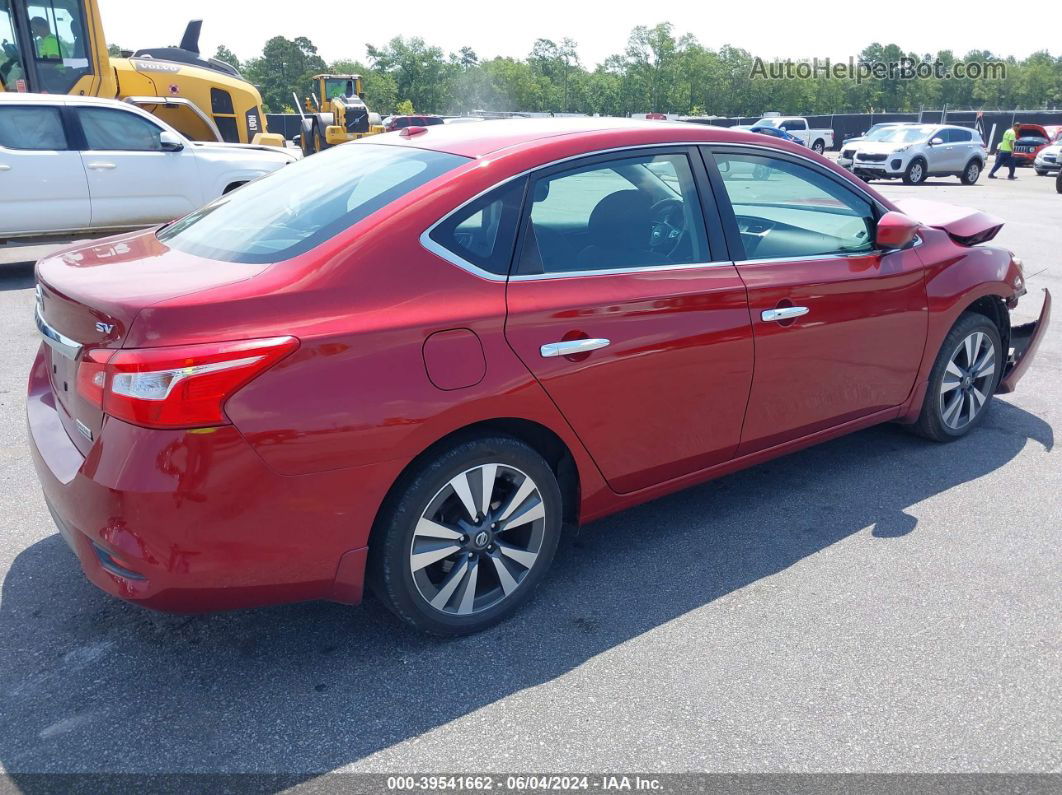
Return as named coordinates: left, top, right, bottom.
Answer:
left=506, top=148, right=753, bottom=492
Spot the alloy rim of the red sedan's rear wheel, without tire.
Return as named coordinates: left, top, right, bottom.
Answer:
left=409, top=464, right=546, bottom=616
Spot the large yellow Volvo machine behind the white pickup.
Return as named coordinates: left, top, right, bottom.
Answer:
left=0, top=0, right=284, bottom=146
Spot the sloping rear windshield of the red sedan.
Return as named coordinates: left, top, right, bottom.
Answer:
left=158, top=143, right=468, bottom=263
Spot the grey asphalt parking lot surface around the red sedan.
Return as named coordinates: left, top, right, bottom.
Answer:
left=0, top=170, right=1062, bottom=784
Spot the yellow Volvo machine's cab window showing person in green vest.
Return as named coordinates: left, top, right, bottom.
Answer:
left=26, top=0, right=91, bottom=93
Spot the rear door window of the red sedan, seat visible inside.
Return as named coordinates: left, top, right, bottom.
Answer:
left=517, top=154, right=708, bottom=274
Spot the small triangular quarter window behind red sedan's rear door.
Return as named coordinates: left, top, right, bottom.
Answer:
left=429, top=179, right=526, bottom=276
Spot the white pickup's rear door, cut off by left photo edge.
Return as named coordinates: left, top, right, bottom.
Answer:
left=0, top=103, right=89, bottom=236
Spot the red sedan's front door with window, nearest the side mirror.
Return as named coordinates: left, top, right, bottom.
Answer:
left=708, top=148, right=927, bottom=454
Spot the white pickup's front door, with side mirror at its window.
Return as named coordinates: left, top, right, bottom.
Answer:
left=75, top=105, right=203, bottom=227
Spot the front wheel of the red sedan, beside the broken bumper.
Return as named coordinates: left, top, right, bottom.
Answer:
left=913, top=313, right=1004, bottom=442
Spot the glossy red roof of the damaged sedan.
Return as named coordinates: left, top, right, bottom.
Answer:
left=365, top=117, right=763, bottom=158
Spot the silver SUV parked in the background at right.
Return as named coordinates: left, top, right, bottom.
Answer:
left=852, top=124, right=988, bottom=185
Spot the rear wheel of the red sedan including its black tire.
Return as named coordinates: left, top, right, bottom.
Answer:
left=369, top=436, right=563, bottom=636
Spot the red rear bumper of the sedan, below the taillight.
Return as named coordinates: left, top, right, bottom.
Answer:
left=27, top=343, right=387, bottom=612
